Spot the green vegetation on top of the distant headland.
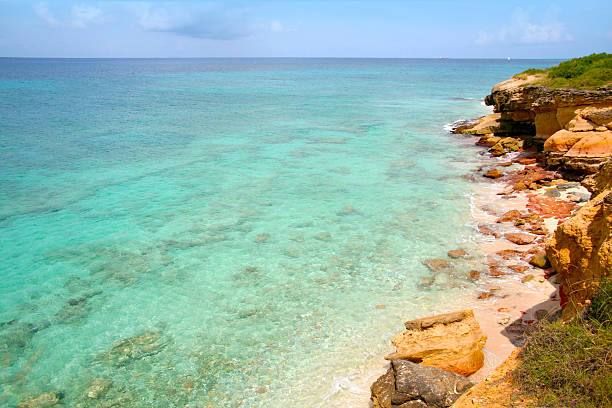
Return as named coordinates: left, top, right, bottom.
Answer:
left=514, top=52, right=612, bottom=89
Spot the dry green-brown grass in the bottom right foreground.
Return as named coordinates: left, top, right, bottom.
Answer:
left=514, top=282, right=612, bottom=408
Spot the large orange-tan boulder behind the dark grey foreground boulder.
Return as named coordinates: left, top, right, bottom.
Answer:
left=385, top=310, right=487, bottom=376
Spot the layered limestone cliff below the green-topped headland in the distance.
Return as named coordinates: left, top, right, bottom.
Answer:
left=485, top=78, right=612, bottom=173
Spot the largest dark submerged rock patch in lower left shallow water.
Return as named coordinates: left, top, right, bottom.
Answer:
left=95, top=331, right=166, bottom=367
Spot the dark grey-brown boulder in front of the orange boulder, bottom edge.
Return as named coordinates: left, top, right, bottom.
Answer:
left=370, top=359, right=473, bottom=408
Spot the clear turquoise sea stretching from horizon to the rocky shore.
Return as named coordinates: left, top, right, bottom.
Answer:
left=0, top=59, right=554, bottom=407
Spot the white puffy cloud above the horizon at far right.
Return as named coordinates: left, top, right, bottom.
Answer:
left=476, top=8, right=574, bottom=45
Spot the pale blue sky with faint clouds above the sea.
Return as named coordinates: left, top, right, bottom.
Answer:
left=0, top=0, right=612, bottom=59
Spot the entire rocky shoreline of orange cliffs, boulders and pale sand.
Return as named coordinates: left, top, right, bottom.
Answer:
left=371, top=78, right=612, bottom=408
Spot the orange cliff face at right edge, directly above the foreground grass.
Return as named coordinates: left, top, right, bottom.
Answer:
left=546, top=159, right=612, bottom=320
